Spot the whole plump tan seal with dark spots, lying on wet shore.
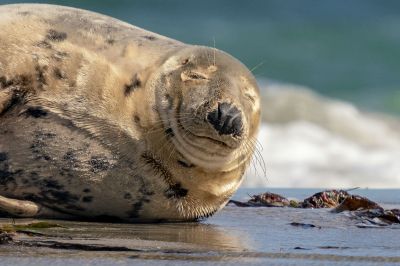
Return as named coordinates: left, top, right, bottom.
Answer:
left=0, top=5, right=260, bottom=222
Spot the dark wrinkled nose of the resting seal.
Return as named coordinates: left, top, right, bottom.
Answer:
left=207, top=102, right=243, bottom=137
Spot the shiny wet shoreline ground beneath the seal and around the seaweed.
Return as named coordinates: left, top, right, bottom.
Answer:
left=0, top=189, right=400, bottom=265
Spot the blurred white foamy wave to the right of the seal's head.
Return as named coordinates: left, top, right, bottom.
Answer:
left=243, top=84, right=400, bottom=188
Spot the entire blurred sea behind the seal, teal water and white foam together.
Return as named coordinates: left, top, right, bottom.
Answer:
left=0, top=0, right=400, bottom=188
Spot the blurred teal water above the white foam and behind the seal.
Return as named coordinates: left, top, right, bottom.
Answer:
left=0, top=0, right=400, bottom=114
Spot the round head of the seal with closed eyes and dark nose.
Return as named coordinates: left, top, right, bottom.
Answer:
left=152, top=46, right=260, bottom=172
